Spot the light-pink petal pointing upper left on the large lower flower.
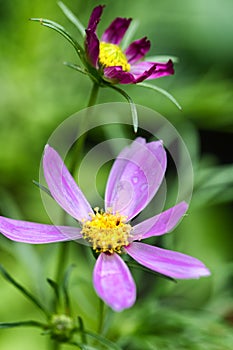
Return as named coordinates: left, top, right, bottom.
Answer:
left=43, top=145, right=93, bottom=221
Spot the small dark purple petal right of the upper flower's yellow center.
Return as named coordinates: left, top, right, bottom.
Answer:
left=125, top=37, right=150, bottom=64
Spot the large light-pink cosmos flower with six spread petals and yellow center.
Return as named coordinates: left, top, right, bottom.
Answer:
left=0, top=138, right=210, bottom=311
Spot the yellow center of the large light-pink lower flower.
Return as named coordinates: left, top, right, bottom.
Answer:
left=81, top=208, right=131, bottom=254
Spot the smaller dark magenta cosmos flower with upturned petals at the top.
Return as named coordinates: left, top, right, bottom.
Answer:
left=85, top=6, right=174, bottom=84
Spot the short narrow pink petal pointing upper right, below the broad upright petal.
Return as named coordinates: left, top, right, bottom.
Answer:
left=131, top=202, right=188, bottom=241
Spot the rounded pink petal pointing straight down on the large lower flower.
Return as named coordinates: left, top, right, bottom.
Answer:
left=93, top=253, right=136, bottom=311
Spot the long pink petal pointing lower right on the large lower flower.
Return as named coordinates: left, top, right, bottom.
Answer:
left=125, top=242, right=210, bottom=279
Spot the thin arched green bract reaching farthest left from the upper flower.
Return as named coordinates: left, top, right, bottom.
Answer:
left=30, top=18, right=84, bottom=61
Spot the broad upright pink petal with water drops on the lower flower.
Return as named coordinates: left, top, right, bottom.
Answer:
left=105, top=137, right=166, bottom=220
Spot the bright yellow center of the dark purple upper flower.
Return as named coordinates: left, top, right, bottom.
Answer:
left=99, top=42, right=130, bottom=72
